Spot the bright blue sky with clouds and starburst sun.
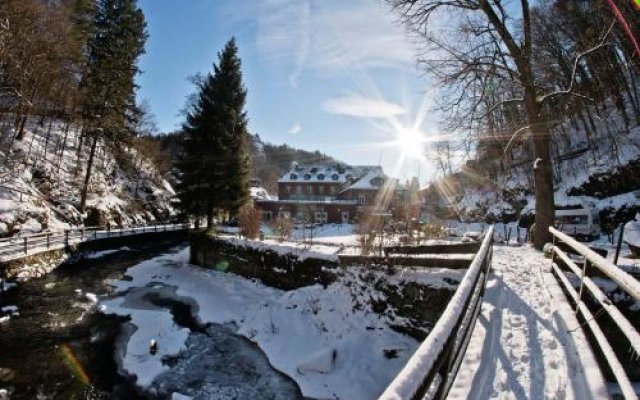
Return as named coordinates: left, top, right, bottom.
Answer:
left=138, top=0, right=438, bottom=182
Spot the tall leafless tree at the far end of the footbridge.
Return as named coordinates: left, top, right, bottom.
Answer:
left=387, top=0, right=620, bottom=248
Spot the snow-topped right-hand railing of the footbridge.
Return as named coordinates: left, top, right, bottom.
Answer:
left=549, top=227, right=640, bottom=399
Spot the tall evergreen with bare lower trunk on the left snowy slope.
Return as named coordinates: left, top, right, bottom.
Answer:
left=80, top=0, right=147, bottom=211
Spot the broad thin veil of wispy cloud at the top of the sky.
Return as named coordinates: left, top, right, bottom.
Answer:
left=249, top=0, right=415, bottom=87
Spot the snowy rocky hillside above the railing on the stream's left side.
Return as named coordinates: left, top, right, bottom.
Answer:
left=0, top=118, right=176, bottom=236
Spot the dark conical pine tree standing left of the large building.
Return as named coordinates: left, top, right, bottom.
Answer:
left=180, top=38, right=250, bottom=227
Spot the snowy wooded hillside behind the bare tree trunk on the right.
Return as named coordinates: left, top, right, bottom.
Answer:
left=427, top=107, right=640, bottom=231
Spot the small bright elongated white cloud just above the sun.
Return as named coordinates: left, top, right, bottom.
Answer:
left=322, top=95, right=406, bottom=119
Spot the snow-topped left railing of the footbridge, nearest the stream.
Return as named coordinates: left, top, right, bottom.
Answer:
left=380, top=226, right=493, bottom=400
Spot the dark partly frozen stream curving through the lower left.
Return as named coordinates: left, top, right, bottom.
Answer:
left=0, top=243, right=302, bottom=400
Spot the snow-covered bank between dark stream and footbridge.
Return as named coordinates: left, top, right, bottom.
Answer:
left=101, top=249, right=444, bottom=400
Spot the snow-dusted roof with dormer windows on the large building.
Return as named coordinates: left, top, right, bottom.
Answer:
left=278, top=164, right=382, bottom=184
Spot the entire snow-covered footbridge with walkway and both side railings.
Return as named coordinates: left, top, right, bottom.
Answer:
left=379, top=228, right=640, bottom=400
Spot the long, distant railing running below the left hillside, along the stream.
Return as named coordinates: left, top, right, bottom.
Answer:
left=0, top=223, right=190, bottom=262
